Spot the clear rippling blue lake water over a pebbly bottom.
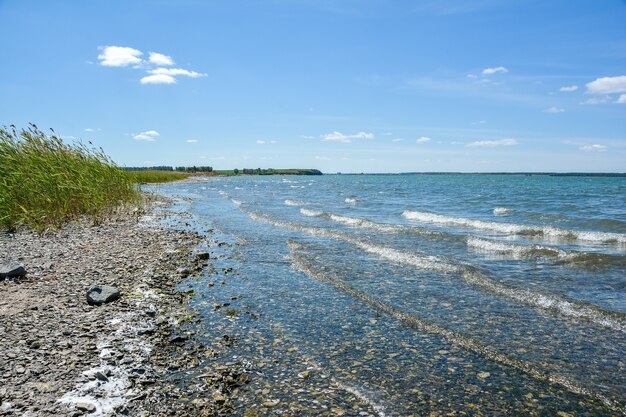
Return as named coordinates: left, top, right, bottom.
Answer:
left=150, top=175, right=626, bottom=416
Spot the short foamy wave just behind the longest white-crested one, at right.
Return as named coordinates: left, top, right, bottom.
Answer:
left=467, top=236, right=626, bottom=267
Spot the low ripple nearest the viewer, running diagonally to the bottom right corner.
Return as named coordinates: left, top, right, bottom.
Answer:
left=287, top=242, right=623, bottom=412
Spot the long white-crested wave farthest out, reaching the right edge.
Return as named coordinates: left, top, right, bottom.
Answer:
left=402, top=210, right=626, bottom=244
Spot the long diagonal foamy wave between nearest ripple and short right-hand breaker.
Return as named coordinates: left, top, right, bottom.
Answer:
left=248, top=209, right=626, bottom=333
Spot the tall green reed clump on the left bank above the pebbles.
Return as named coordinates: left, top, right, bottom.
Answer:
left=0, top=124, right=140, bottom=231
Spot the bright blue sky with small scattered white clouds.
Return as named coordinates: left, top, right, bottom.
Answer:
left=0, top=0, right=626, bottom=172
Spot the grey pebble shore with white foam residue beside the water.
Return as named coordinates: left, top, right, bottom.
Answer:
left=0, top=200, right=236, bottom=416
